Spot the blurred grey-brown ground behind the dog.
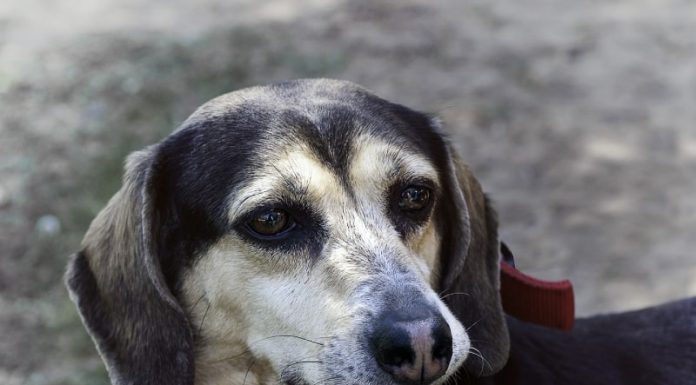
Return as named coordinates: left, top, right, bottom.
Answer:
left=0, top=0, right=696, bottom=385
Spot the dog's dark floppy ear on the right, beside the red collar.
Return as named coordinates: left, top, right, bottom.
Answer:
left=440, top=145, right=510, bottom=376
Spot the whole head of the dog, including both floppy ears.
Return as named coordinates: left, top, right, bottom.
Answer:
left=67, top=80, right=507, bottom=385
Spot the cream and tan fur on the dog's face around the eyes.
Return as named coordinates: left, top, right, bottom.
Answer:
left=183, top=136, right=468, bottom=385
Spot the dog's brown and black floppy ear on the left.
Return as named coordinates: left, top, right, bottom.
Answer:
left=65, top=146, right=194, bottom=385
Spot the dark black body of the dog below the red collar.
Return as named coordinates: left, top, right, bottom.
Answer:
left=478, top=298, right=696, bottom=385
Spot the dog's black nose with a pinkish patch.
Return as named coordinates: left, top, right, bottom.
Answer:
left=370, top=313, right=452, bottom=385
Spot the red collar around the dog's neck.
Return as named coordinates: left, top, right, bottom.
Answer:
left=500, top=242, right=575, bottom=330
